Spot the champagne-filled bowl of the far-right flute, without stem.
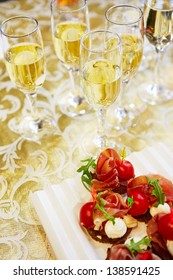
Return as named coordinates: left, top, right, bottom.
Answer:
left=144, top=0, right=173, bottom=51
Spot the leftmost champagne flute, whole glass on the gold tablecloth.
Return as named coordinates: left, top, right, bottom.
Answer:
left=1, top=16, right=56, bottom=141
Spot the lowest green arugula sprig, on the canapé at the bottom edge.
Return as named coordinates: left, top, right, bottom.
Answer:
left=125, top=236, right=151, bottom=256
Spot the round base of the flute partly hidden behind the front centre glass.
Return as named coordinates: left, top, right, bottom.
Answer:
left=107, top=104, right=140, bottom=130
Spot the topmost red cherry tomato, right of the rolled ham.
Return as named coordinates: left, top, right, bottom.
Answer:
left=117, top=160, right=135, bottom=180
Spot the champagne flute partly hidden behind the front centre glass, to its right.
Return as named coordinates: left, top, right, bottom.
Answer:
left=105, top=4, right=144, bottom=130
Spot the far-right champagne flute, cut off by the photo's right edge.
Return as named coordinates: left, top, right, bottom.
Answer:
left=139, top=0, right=173, bottom=105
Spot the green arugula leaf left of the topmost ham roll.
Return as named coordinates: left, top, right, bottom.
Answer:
left=77, top=157, right=96, bottom=191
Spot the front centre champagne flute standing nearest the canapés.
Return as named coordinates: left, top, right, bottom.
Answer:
left=80, top=30, right=121, bottom=154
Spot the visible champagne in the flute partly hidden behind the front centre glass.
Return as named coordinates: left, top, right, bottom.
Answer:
left=121, top=34, right=143, bottom=80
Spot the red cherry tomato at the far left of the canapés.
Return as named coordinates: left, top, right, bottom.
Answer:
left=79, top=202, right=95, bottom=228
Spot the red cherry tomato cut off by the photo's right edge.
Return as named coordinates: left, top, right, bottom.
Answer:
left=158, top=210, right=173, bottom=240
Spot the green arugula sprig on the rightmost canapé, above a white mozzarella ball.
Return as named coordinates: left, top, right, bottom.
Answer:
left=146, top=177, right=165, bottom=207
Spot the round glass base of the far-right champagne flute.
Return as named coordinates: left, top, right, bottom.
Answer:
left=139, top=84, right=173, bottom=105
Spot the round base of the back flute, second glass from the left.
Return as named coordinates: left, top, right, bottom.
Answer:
left=58, top=91, right=92, bottom=118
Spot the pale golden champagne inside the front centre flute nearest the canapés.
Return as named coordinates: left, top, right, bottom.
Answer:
left=82, top=59, right=121, bottom=107
